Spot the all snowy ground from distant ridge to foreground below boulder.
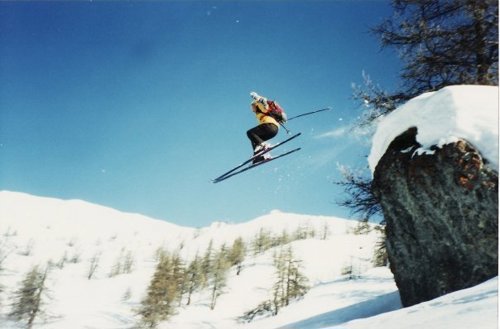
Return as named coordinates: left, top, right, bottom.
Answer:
left=0, top=191, right=497, bottom=329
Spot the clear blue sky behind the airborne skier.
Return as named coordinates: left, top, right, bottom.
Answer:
left=0, top=0, right=400, bottom=226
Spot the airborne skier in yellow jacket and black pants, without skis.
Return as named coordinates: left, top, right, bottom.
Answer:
left=247, top=91, right=280, bottom=163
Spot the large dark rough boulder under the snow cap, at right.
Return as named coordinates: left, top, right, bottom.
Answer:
left=372, top=127, right=498, bottom=306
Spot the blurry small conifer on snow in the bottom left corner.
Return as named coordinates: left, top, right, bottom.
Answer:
left=9, top=266, right=49, bottom=328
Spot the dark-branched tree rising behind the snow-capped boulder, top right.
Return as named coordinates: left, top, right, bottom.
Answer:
left=354, top=0, right=498, bottom=123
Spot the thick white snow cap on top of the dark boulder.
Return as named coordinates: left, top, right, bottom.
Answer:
left=368, top=85, right=499, bottom=173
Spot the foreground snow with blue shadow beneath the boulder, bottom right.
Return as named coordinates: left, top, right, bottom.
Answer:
left=283, top=278, right=498, bottom=329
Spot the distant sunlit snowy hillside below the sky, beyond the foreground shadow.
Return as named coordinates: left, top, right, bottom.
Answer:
left=0, top=191, right=382, bottom=329
